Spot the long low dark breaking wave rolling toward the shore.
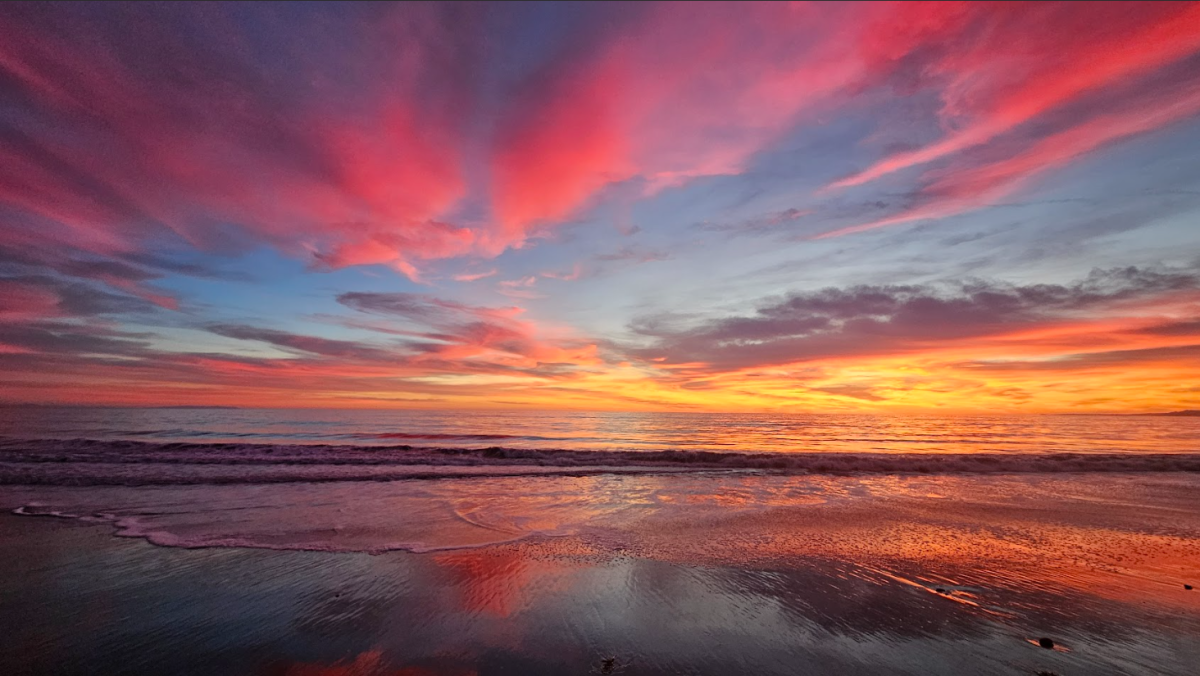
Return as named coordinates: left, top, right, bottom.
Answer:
left=0, top=439, right=1200, bottom=485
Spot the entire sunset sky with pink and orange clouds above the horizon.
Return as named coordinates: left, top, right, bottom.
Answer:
left=0, top=2, right=1200, bottom=413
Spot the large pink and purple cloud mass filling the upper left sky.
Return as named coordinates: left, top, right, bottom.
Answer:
left=0, top=6, right=476, bottom=283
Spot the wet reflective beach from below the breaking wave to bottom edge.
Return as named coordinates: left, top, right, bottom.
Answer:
left=0, top=475, right=1200, bottom=676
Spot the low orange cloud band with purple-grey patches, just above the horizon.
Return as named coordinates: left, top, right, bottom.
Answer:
left=0, top=268, right=1200, bottom=412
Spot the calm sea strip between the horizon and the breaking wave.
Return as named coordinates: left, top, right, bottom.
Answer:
left=0, top=407, right=1200, bottom=454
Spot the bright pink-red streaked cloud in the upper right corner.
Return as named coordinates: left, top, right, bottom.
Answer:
left=830, top=2, right=1200, bottom=187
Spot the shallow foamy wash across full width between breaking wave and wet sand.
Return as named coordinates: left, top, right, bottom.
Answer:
left=14, top=472, right=1200, bottom=556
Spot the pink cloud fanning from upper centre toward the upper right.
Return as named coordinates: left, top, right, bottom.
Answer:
left=492, top=4, right=860, bottom=243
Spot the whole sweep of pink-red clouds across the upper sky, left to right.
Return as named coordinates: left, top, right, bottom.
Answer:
left=0, top=2, right=1200, bottom=296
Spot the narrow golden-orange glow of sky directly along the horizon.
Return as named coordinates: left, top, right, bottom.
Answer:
left=8, top=323, right=1200, bottom=413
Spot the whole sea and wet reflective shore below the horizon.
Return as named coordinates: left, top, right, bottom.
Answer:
left=0, top=407, right=1200, bottom=676
